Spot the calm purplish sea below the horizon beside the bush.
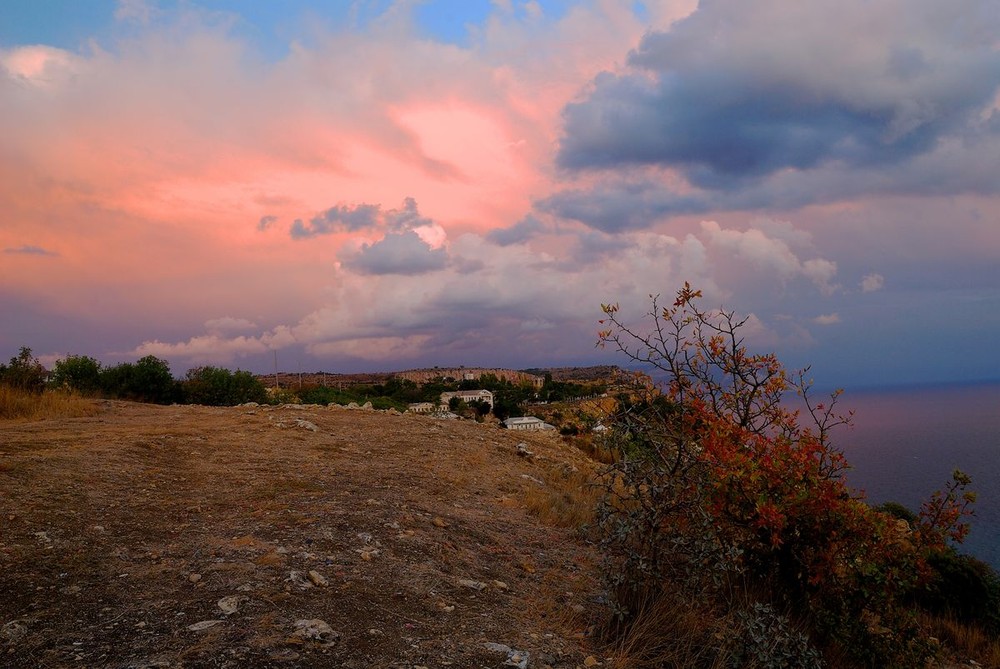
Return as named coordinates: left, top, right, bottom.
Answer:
left=834, top=383, right=1000, bottom=569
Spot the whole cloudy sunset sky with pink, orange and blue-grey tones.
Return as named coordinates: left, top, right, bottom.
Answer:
left=0, top=0, right=1000, bottom=389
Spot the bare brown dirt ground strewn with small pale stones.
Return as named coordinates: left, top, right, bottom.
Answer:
left=0, top=402, right=603, bottom=669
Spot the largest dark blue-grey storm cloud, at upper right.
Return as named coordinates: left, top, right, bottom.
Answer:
left=558, top=0, right=1000, bottom=193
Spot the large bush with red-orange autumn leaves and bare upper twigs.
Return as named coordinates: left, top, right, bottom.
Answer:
left=599, top=284, right=974, bottom=666
